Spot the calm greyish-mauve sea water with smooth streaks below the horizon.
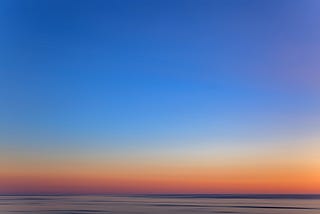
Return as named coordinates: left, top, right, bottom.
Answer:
left=0, top=195, right=320, bottom=214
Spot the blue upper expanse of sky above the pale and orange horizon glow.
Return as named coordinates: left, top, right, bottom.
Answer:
left=0, top=0, right=320, bottom=150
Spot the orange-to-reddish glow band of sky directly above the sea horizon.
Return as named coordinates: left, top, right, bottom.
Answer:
left=0, top=158, right=320, bottom=193
